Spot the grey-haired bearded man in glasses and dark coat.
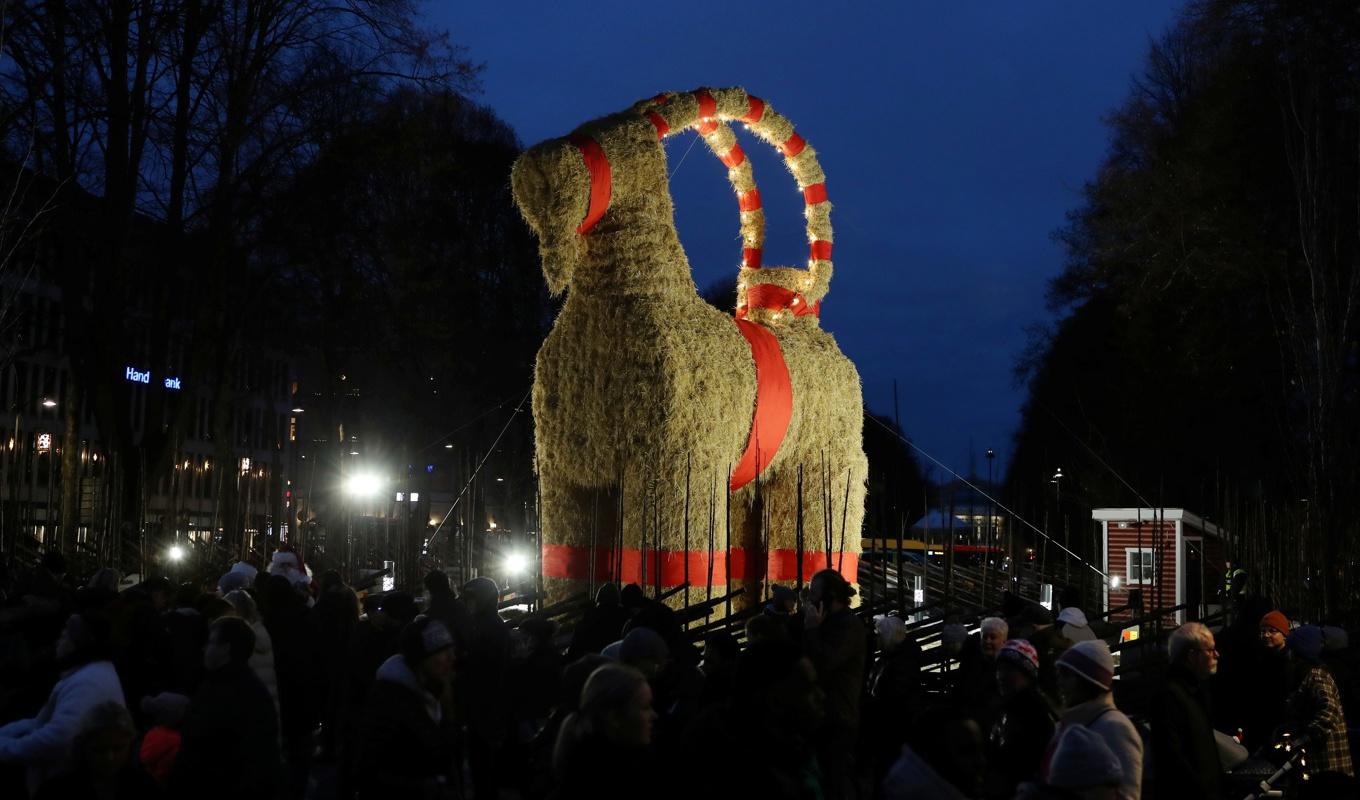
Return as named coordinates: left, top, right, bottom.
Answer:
left=1148, top=622, right=1223, bottom=799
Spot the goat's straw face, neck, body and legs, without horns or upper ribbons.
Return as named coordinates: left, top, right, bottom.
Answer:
left=514, top=90, right=868, bottom=601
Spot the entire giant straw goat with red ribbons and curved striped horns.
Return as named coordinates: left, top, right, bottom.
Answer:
left=513, top=88, right=868, bottom=603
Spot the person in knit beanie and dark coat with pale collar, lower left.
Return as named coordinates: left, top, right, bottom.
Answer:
left=355, top=616, right=460, bottom=800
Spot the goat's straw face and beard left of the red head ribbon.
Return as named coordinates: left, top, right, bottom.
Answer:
left=510, top=139, right=590, bottom=295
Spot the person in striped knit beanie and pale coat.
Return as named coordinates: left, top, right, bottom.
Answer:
left=1050, top=639, right=1142, bottom=800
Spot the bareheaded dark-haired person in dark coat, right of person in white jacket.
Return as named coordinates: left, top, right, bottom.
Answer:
left=169, top=616, right=283, bottom=800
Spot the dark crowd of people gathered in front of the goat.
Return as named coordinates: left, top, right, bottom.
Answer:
left=0, top=552, right=1355, bottom=800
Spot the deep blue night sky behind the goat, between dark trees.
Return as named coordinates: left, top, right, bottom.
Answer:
left=426, top=0, right=1182, bottom=476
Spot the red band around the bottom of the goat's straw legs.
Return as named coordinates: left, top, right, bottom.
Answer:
left=543, top=541, right=860, bottom=586
